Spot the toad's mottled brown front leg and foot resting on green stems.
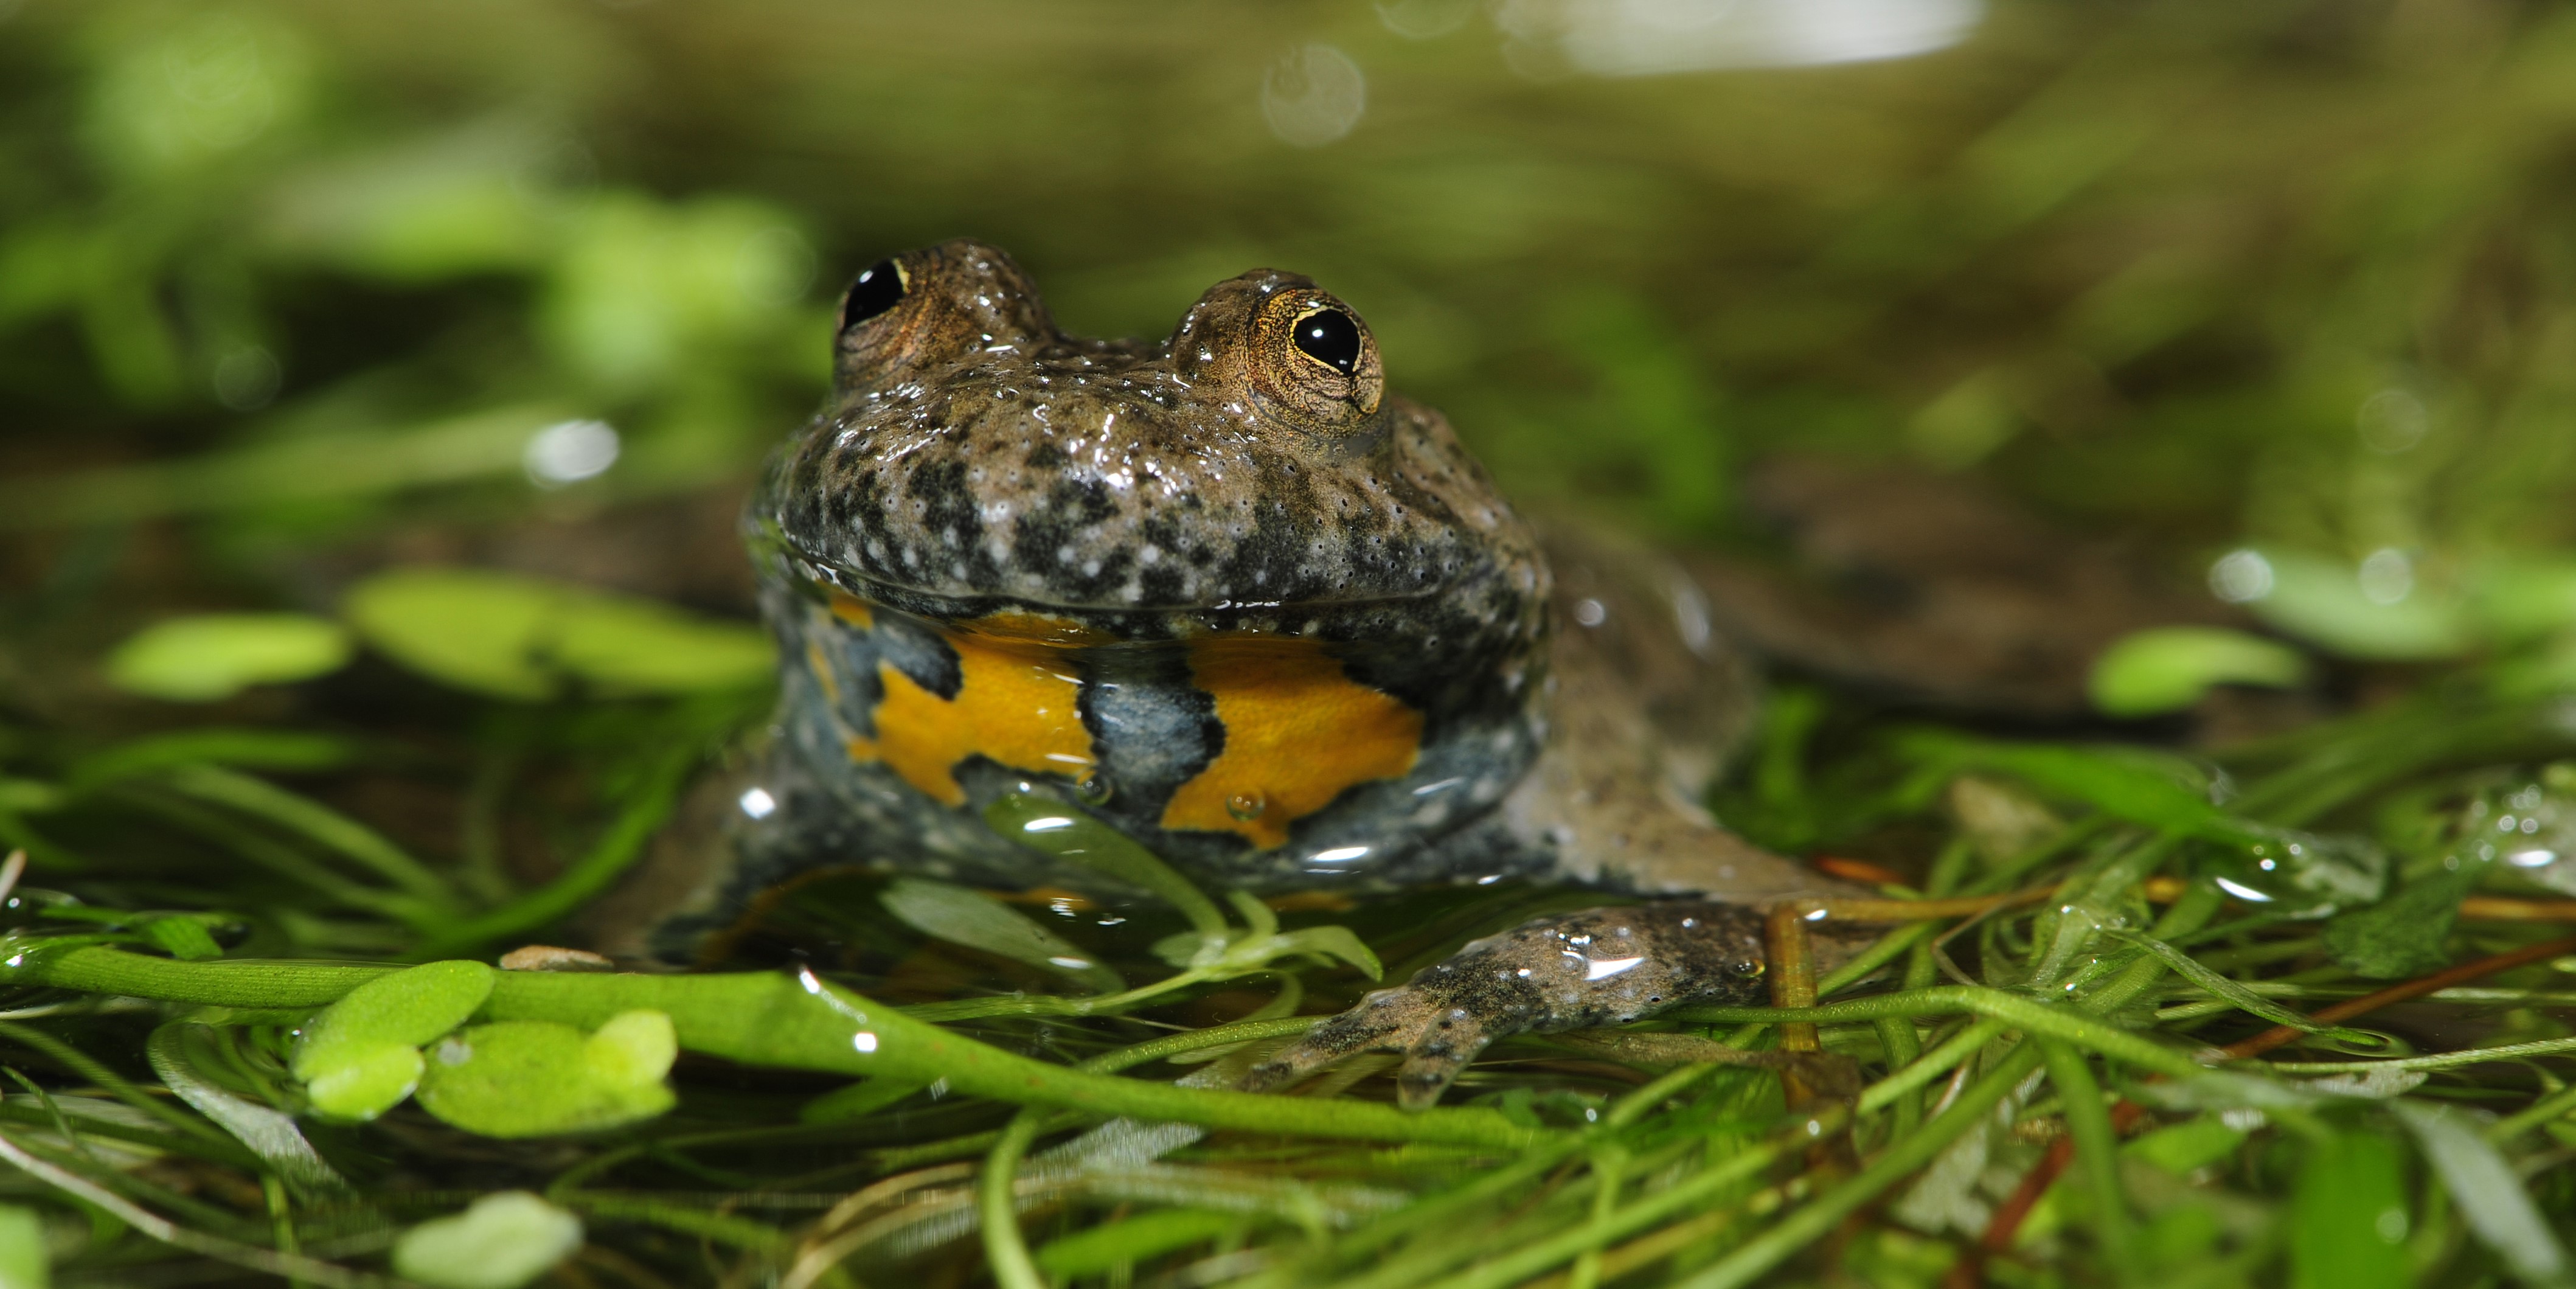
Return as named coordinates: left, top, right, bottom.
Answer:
left=1245, top=900, right=1765, bottom=1108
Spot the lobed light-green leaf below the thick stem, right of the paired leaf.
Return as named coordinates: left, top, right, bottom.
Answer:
left=420, top=1010, right=678, bottom=1137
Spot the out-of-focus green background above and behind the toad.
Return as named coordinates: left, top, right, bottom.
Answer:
left=0, top=0, right=2576, bottom=689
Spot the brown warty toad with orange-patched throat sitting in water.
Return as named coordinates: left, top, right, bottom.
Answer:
left=608, top=242, right=1834, bottom=1103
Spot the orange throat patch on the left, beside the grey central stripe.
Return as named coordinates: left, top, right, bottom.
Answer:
left=847, top=614, right=1092, bottom=804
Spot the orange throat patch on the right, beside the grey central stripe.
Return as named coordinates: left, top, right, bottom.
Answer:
left=1162, top=634, right=1422, bottom=851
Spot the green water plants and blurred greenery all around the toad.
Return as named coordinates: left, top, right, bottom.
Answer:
left=0, top=0, right=2576, bottom=1289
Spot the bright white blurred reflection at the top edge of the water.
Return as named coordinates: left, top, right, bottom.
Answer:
left=1494, top=0, right=1986, bottom=75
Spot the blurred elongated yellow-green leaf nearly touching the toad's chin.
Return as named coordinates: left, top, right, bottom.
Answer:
left=345, top=567, right=773, bottom=698
